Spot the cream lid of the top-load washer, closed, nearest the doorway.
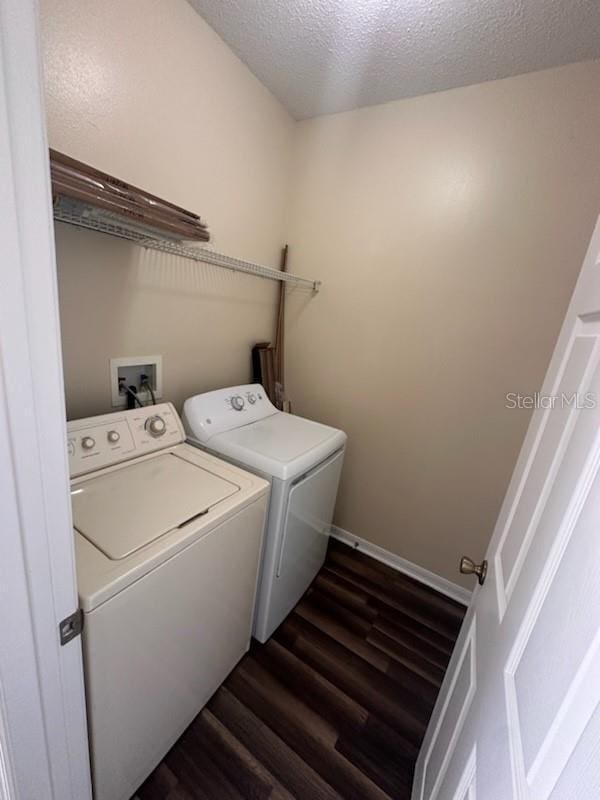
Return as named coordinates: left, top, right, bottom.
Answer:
left=71, top=453, right=240, bottom=560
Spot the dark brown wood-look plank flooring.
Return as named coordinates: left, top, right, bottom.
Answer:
left=136, top=540, right=465, bottom=800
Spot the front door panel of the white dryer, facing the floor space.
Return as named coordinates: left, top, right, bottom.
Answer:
left=277, top=450, right=344, bottom=588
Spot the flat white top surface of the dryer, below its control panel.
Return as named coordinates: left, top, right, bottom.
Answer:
left=207, top=411, right=346, bottom=480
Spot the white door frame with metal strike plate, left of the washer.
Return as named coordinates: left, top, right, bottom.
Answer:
left=0, top=0, right=91, bottom=800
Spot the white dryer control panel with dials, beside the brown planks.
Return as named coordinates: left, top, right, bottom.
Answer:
left=183, top=383, right=279, bottom=442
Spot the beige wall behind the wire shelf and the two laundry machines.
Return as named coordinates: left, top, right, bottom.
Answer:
left=41, top=0, right=293, bottom=417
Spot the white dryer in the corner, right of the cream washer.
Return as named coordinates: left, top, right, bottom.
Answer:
left=183, top=384, right=346, bottom=642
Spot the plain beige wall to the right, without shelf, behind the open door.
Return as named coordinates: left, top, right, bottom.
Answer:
left=287, top=62, right=600, bottom=585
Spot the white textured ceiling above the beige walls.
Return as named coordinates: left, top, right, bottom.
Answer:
left=189, top=0, right=600, bottom=119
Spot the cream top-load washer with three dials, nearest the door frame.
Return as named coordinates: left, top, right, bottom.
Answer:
left=67, top=403, right=269, bottom=800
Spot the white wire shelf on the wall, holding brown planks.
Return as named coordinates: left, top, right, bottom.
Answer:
left=54, top=198, right=321, bottom=292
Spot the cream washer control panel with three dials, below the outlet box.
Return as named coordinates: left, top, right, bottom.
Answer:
left=67, top=403, right=185, bottom=478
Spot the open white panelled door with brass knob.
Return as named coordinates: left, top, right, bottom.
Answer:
left=412, top=217, right=600, bottom=800
